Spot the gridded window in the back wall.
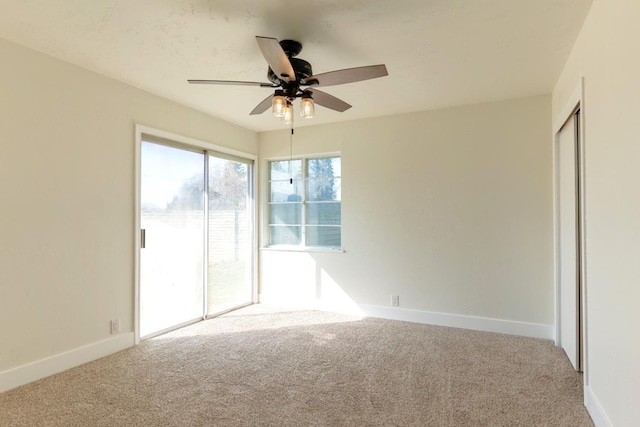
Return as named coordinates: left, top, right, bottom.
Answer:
left=268, top=156, right=342, bottom=248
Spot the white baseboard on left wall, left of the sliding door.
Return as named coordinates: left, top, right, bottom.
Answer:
left=0, top=332, right=134, bottom=393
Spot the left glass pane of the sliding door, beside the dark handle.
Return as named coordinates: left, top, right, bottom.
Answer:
left=140, top=142, right=204, bottom=337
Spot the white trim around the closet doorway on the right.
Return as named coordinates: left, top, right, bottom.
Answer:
left=552, top=77, right=589, bottom=378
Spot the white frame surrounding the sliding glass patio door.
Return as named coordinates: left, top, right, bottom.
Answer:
left=133, top=124, right=259, bottom=344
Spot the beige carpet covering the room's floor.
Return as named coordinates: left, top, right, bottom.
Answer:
left=0, top=306, right=593, bottom=427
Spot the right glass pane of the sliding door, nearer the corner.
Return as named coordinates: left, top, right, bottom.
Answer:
left=207, top=156, right=253, bottom=314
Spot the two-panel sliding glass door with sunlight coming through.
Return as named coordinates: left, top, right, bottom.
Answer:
left=139, top=139, right=254, bottom=338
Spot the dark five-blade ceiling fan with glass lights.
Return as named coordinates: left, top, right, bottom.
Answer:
left=187, top=36, right=388, bottom=123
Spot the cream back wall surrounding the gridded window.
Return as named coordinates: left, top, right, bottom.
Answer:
left=259, top=96, right=554, bottom=337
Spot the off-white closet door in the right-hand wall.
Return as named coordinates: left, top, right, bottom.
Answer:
left=556, top=114, right=580, bottom=370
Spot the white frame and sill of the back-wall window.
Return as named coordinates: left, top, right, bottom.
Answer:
left=261, top=152, right=344, bottom=252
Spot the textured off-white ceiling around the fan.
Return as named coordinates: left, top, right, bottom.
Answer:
left=0, top=0, right=592, bottom=131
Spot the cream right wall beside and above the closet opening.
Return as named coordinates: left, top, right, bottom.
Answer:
left=553, top=0, right=640, bottom=426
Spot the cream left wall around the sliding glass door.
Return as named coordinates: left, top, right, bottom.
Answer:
left=0, top=40, right=257, bottom=382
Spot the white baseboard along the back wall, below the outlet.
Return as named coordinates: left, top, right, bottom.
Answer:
left=358, top=304, right=554, bottom=340
